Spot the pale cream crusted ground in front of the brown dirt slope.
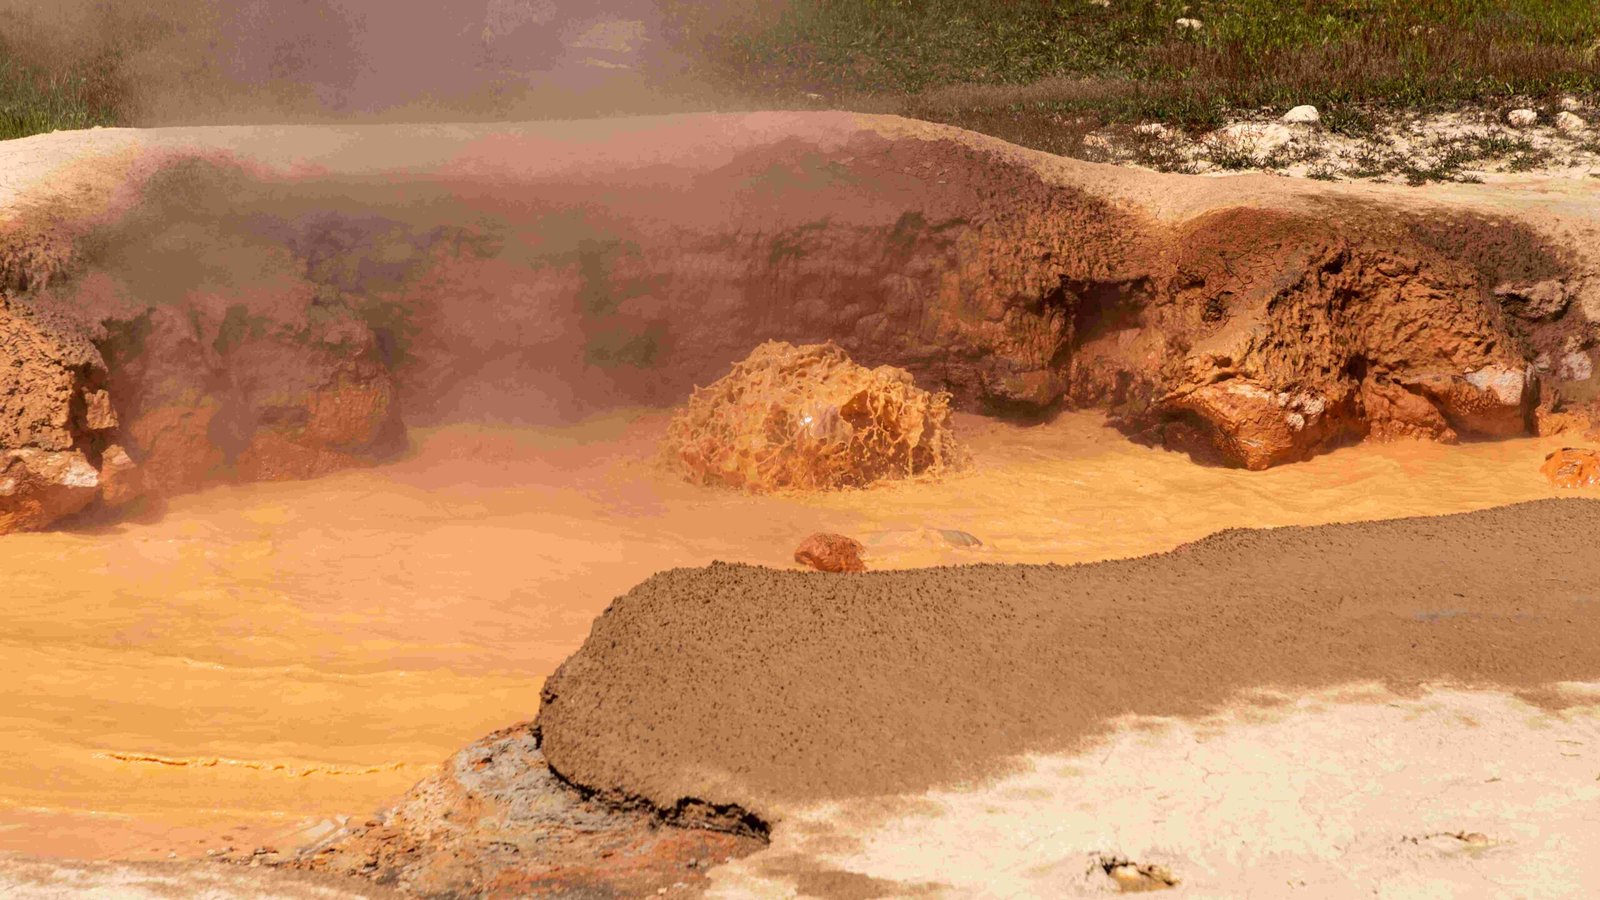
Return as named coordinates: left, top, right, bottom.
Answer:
left=709, top=685, right=1600, bottom=900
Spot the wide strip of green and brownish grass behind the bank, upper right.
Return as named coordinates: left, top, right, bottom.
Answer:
left=662, top=0, right=1600, bottom=152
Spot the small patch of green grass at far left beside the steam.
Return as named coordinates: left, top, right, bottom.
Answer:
left=0, top=40, right=122, bottom=141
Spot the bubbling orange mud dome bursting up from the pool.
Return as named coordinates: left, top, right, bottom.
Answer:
left=664, top=341, right=958, bottom=492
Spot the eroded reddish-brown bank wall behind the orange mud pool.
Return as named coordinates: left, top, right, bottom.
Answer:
left=0, top=117, right=1600, bottom=530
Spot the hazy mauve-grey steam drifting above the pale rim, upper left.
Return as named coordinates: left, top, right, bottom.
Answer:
left=0, top=0, right=750, bottom=125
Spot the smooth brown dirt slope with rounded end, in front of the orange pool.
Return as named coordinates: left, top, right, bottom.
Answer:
left=538, top=500, right=1600, bottom=822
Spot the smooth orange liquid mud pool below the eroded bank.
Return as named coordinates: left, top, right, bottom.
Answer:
left=0, top=412, right=1562, bottom=858
